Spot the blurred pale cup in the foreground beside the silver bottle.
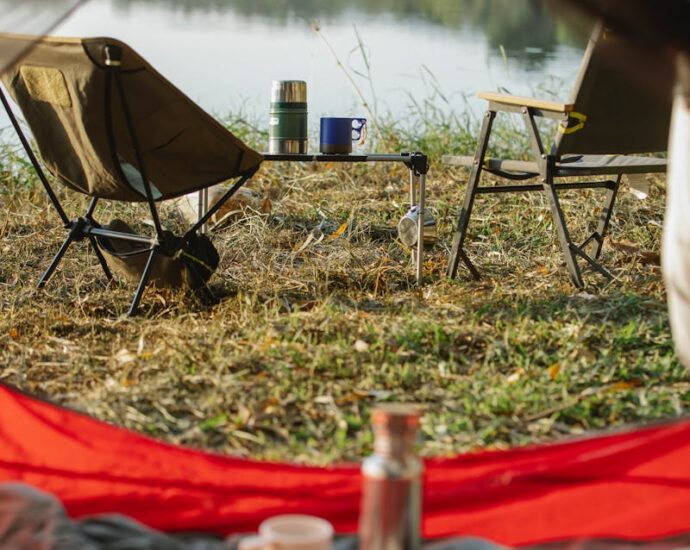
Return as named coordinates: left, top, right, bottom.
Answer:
left=239, top=514, right=333, bottom=550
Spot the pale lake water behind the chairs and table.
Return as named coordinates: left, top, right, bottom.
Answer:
left=45, top=0, right=582, bottom=126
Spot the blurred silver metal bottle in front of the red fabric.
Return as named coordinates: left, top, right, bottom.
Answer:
left=359, top=404, right=424, bottom=550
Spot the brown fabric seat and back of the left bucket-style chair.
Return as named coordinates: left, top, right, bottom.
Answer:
left=0, top=35, right=262, bottom=201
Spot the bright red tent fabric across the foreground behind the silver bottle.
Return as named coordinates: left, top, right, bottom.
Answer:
left=0, top=385, right=690, bottom=546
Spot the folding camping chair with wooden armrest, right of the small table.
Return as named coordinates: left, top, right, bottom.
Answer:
left=443, top=23, right=672, bottom=288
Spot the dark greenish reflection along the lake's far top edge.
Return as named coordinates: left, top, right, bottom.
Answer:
left=114, top=0, right=583, bottom=68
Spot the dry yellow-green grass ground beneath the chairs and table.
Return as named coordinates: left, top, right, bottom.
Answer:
left=0, top=118, right=690, bottom=464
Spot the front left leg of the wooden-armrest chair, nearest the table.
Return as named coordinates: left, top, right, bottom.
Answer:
left=447, top=111, right=496, bottom=279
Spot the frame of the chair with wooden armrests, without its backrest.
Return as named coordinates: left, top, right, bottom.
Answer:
left=444, top=93, right=644, bottom=288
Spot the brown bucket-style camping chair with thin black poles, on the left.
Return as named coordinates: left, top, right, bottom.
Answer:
left=0, top=35, right=262, bottom=315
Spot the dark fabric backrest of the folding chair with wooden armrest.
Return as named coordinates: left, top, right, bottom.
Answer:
left=554, top=23, right=673, bottom=155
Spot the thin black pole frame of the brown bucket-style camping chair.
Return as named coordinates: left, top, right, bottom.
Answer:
left=0, top=45, right=258, bottom=317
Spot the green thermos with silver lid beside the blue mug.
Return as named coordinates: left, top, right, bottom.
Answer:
left=268, top=80, right=307, bottom=154
